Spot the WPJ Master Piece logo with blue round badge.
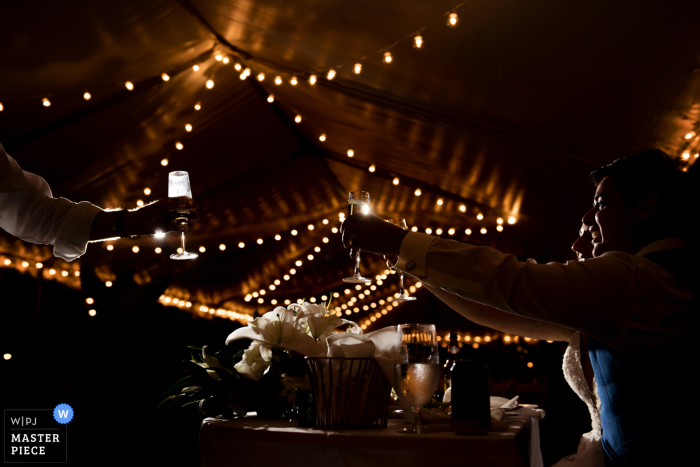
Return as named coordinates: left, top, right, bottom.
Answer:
left=4, top=404, right=73, bottom=464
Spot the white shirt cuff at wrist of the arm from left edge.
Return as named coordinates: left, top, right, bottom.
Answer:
left=53, top=201, right=102, bottom=261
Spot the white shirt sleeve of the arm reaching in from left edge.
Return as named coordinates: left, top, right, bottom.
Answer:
left=0, top=146, right=102, bottom=261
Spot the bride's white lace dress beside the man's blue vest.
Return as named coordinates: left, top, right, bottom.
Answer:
left=552, top=332, right=605, bottom=467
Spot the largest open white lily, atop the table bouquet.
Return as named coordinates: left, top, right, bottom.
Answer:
left=226, top=307, right=323, bottom=357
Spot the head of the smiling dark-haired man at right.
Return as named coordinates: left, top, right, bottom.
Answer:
left=583, top=149, right=689, bottom=256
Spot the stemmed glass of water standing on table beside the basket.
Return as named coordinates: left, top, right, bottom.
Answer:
left=394, top=324, right=440, bottom=434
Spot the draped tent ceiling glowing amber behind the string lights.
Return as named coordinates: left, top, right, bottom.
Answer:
left=0, top=0, right=700, bottom=330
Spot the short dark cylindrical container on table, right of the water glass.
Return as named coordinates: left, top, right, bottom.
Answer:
left=450, top=360, right=491, bottom=435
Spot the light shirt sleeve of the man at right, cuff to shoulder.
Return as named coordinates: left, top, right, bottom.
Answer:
left=396, top=232, right=692, bottom=348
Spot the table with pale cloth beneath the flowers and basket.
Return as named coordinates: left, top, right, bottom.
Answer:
left=199, top=407, right=543, bottom=467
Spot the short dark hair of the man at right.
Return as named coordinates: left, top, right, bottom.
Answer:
left=590, top=149, right=692, bottom=236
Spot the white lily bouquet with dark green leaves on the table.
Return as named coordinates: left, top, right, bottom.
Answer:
left=157, top=302, right=362, bottom=418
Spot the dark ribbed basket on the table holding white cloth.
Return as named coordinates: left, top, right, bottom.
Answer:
left=306, top=357, right=391, bottom=428
